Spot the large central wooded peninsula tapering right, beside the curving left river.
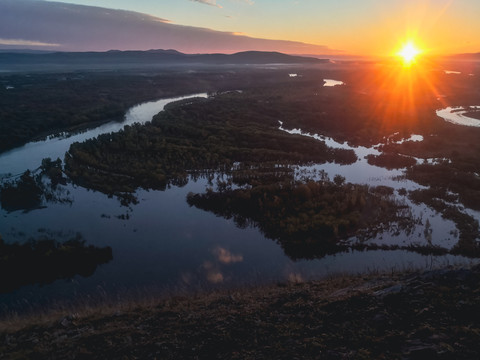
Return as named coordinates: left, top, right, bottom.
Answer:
left=65, top=93, right=357, bottom=194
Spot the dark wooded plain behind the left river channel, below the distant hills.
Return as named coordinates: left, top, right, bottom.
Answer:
left=0, top=69, right=316, bottom=152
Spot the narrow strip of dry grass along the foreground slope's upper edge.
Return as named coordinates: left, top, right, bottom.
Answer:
left=0, top=271, right=404, bottom=333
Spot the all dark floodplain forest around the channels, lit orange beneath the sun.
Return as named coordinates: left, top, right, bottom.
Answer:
left=0, top=65, right=480, bottom=258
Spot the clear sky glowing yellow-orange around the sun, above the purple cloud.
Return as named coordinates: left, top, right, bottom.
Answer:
left=0, top=0, right=480, bottom=56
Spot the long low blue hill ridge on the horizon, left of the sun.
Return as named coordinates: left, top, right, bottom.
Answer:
left=0, top=50, right=328, bottom=70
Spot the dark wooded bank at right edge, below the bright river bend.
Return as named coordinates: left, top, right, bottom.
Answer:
left=382, top=129, right=480, bottom=257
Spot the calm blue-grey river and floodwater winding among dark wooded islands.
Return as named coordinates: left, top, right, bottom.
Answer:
left=0, top=86, right=469, bottom=312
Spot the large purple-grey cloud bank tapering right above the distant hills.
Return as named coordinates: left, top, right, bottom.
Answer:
left=0, top=0, right=338, bottom=55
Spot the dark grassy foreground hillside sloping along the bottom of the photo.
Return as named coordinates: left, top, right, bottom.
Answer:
left=0, top=266, right=480, bottom=359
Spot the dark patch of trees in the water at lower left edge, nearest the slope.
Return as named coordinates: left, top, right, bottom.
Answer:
left=0, top=235, right=112, bottom=293
